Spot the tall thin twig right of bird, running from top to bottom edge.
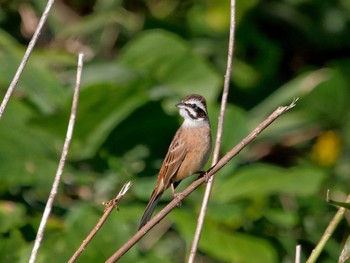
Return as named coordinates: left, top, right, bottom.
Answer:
left=188, top=0, right=236, bottom=263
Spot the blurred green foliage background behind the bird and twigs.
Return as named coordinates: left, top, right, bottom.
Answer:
left=0, top=0, right=350, bottom=263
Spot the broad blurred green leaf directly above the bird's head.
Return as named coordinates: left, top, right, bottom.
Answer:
left=119, top=30, right=221, bottom=101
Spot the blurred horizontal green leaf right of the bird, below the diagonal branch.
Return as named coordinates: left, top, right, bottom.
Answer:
left=213, top=164, right=326, bottom=202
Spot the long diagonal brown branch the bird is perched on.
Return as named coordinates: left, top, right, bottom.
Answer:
left=106, top=100, right=296, bottom=263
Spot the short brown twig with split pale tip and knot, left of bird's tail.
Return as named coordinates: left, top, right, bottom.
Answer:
left=68, top=182, right=131, bottom=263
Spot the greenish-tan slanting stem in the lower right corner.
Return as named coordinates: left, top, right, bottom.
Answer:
left=306, top=192, right=350, bottom=263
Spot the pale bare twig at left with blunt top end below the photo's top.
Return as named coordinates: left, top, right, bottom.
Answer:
left=29, top=53, right=84, bottom=263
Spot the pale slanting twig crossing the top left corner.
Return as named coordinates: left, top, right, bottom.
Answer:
left=0, top=0, right=55, bottom=120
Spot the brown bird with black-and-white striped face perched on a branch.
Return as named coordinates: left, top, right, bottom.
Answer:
left=138, top=94, right=212, bottom=230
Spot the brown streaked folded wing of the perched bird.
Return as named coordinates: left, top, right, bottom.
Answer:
left=158, top=129, right=188, bottom=191
